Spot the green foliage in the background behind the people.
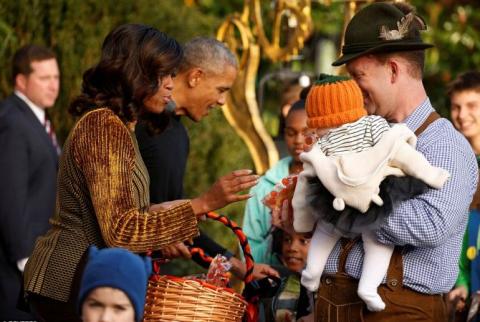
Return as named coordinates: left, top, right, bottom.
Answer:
left=0, top=0, right=480, bottom=274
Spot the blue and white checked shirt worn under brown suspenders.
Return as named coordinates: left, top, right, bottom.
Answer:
left=325, top=98, right=478, bottom=294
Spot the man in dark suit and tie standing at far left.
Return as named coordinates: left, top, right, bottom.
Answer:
left=0, top=45, right=59, bottom=320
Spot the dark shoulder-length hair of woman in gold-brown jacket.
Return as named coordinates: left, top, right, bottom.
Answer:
left=69, top=24, right=183, bottom=130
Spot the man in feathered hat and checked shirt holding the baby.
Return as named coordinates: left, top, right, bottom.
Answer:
left=315, top=2, right=478, bottom=322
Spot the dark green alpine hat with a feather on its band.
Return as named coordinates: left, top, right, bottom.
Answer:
left=332, top=2, right=433, bottom=66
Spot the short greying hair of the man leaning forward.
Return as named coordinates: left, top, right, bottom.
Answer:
left=180, top=37, right=238, bottom=73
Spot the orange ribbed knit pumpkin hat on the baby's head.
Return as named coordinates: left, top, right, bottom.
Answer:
left=305, top=74, right=367, bottom=128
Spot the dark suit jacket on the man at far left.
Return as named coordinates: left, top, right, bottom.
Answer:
left=0, top=95, right=58, bottom=320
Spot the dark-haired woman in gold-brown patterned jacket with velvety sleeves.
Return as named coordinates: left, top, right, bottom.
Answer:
left=24, top=24, right=244, bottom=321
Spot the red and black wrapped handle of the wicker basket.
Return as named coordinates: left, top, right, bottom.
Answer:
left=190, top=212, right=254, bottom=283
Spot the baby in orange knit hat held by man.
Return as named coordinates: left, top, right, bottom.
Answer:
left=292, top=75, right=450, bottom=311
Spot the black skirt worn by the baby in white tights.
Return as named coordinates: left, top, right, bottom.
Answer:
left=306, top=176, right=429, bottom=238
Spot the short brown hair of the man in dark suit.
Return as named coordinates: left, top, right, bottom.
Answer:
left=12, top=45, right=57, bottom=84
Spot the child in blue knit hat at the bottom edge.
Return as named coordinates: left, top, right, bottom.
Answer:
left=78, top=246, right=152, bottom=322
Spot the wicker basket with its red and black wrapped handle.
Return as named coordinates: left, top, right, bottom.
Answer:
left=144, top=213, right=253, bottom=322
